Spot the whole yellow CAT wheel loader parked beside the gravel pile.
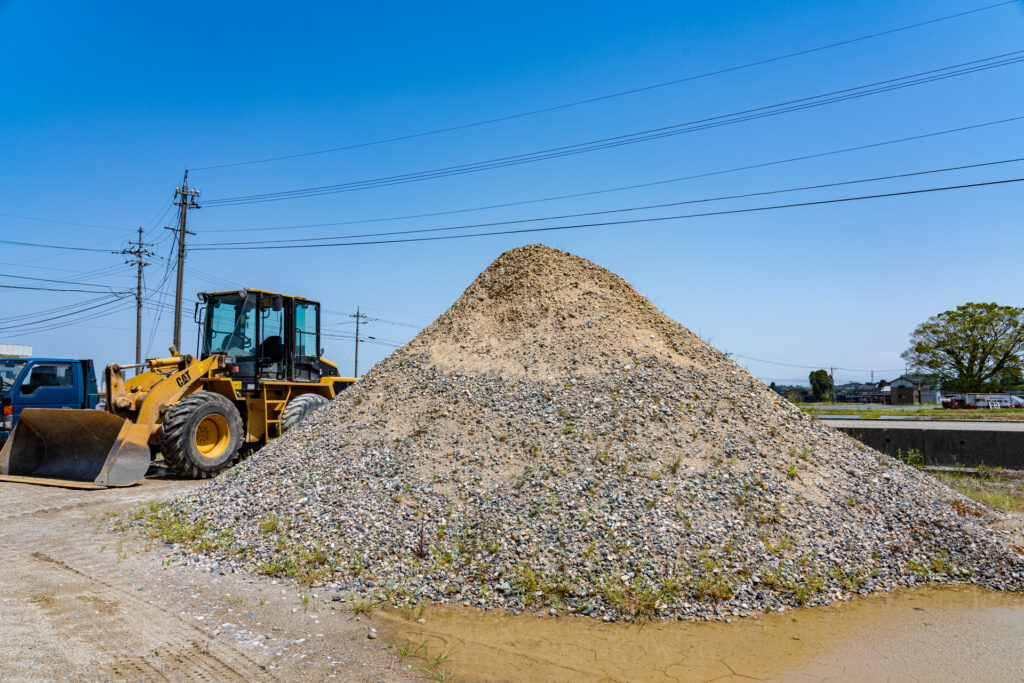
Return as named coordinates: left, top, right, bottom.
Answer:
left=0, top=290, right=355, bottom=488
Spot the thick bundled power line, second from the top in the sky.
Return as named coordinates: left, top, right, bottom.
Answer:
left=199, top=50, right=1024, bottom=207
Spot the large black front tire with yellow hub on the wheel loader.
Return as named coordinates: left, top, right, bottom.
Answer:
left=160, top=391, right=245, bottom=479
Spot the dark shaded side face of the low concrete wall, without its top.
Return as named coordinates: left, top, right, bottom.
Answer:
left=836, top=420, right=1024, bottom=469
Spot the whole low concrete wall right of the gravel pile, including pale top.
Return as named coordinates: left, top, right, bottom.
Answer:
left=823, top=420, right=1024, bottom=469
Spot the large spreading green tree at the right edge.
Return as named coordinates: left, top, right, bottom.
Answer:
left=902, top=303, right=1024, bottom=391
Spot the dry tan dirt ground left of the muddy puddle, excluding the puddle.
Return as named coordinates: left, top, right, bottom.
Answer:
left=0, top=479, right=421, bottom=681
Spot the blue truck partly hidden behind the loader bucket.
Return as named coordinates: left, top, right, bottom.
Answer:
left=0, top=358, right=99, bottom=445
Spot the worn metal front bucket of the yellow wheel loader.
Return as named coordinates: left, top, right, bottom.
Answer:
left=0, top=408, right=150, bottom=488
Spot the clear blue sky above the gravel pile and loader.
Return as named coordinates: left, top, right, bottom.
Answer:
left=0, top=0, right=1024, bottom=381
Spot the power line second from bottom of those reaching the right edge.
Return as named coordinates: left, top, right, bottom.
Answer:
left=195, top=157, right=1024, bottom=247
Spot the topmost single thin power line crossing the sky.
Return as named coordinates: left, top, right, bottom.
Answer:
left=193, top=0, right=1017, bottom=171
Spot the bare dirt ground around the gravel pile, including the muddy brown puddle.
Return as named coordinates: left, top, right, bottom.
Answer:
left=0, top=479, right=1024, bottom=682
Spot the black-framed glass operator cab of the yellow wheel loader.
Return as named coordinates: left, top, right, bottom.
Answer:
left=197, top=290, right=339, bottom=390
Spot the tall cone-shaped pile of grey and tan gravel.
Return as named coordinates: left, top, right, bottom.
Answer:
left=155, top=246, right=1024, bottom=621
